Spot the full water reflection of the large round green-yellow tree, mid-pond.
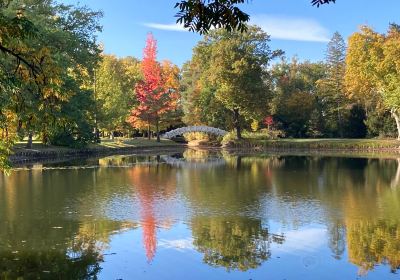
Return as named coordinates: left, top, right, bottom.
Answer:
left=179, top=155, right=284, bottom=271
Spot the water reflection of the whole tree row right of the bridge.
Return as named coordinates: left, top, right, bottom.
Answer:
left=219, top=156, right=400, bottom=270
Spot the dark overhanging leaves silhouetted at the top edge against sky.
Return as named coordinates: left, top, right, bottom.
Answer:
left=175, top=0, right=336, bottom=34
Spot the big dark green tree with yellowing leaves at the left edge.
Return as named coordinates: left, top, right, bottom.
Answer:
left=0, top=0, right=101, bottom=147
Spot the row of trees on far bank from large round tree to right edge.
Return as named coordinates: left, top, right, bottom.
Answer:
left=181, top=24, right=400, bottom=138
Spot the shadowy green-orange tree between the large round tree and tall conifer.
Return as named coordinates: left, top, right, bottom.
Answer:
left=272, top=58, right=326, bottom=137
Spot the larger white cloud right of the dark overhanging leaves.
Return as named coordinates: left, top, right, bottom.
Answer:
left=250, top=15, right=329, bottom=42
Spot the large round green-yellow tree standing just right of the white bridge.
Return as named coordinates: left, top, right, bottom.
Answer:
left=192, top=26, right=282, bottom=139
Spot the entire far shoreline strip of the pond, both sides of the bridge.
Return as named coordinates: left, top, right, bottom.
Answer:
left=9, top=139, right=400, bottom=166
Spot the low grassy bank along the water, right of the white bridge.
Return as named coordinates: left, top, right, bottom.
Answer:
left=225, top=137, right=400, bottom=152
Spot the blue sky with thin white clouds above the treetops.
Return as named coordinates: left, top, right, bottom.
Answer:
left=60, top=0, right=400, bottom=66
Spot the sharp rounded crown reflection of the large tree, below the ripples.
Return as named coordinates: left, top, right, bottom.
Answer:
left=192, top=217, right=284, bottom=271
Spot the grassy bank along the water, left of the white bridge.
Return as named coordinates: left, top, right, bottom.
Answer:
left=10, top=138, right=183, bottom=162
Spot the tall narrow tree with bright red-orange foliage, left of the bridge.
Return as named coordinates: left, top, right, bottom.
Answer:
left=128, top=33, right=177, bottom=142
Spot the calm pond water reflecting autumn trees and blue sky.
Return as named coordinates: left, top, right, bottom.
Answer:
left=0, top=150, right=400, bottom=280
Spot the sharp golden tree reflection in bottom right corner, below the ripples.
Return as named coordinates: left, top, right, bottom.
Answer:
left=347, top=220, right=400, bottom=273
